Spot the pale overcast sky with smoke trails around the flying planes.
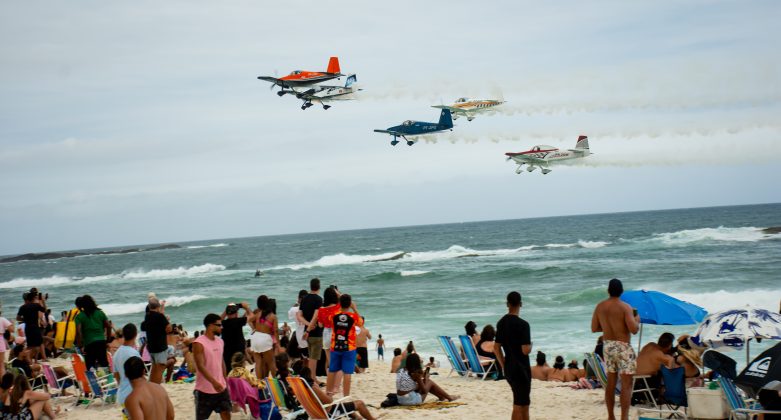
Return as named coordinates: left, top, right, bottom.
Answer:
left=0, top=0, right=781, bottom=254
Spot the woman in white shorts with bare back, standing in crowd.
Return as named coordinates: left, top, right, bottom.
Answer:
left=250, top=295, right=279, bottom=379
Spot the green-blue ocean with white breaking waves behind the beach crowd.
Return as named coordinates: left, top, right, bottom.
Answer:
left=0, top=204, right=781, bottom=363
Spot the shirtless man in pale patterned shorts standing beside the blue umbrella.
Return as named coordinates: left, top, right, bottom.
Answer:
left=591, top=279, right=640, bottom=420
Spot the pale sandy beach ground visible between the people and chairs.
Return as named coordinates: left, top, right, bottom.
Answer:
left=50, top=362, right=634, bottom=420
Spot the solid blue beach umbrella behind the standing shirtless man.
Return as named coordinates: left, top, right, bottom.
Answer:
left=621, top=290, right=708, bottom=349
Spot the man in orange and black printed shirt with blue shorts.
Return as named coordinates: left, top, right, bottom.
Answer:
left=326, top=294, right=363, bottom=397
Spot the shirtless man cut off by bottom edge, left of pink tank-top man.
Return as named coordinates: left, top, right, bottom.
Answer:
left=124, top=356, right=174, bottom=420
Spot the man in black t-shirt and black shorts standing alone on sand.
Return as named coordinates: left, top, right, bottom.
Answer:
left=494, top=292, right=532, bottom=420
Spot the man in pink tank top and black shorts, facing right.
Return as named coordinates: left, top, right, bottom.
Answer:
left=193, top=314, right=232, bottom=420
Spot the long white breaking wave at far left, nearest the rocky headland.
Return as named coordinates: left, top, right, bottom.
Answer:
left=0, top=263, right=225, bottom=289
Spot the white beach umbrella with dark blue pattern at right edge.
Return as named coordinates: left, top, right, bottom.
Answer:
left=692, top=306, right=781, bottom=364
